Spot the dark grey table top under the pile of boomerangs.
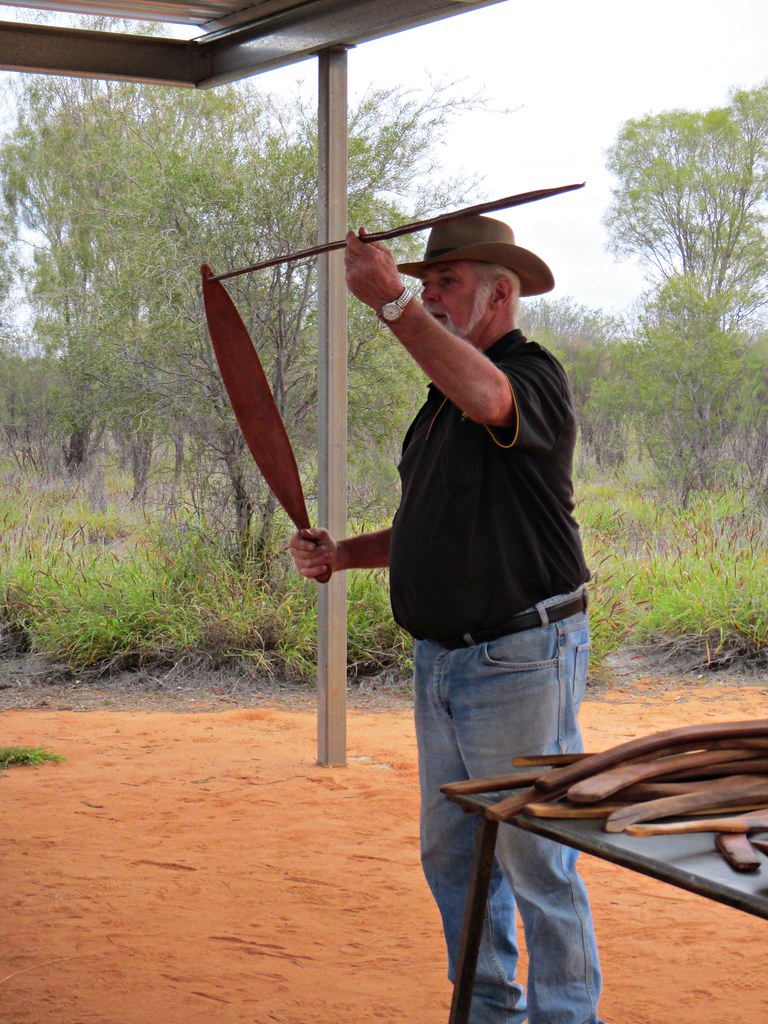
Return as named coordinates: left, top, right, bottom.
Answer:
left=452, top=793, right=768, bottom=920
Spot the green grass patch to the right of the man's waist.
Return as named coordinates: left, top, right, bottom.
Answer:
left=580, top=488, right=768, bottom=669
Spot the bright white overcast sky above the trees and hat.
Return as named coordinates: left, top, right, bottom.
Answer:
left=260, top=0, right=768, bottom=311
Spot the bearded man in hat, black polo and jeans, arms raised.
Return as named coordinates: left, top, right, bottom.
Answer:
left=291, top=216, right=600, bottom=1024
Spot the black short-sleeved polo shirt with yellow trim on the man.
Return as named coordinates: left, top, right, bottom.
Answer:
left=389, top=331, right=589, bottom=640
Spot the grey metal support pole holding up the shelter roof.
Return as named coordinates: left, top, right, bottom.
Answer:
left=317, top=47, right=347, bottom=765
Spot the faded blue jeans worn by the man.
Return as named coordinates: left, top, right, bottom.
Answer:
left=415, top=598, right=601, bottom=1024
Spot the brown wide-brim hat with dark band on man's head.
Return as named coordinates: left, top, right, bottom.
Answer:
left=397, top=216, right=555, bottom=295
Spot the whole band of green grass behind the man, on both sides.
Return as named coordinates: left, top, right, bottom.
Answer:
left=0, top=468, right=768, bottom=683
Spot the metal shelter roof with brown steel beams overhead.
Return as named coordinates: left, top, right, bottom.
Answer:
left=0, top=0, right=505, bottom=87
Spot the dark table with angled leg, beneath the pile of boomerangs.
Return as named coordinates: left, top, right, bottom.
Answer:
left=447, top=793, right=768, bottom=1024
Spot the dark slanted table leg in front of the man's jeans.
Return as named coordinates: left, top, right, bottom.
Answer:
left=449, top=814, right=499, bottom=1024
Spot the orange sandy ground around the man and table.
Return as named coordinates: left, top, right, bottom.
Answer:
left=0, top=677, right=768, bottom=1024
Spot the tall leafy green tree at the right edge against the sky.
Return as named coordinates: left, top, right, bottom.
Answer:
left=603, top=84, right=768, bottom=501
